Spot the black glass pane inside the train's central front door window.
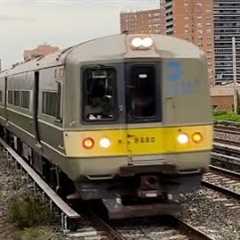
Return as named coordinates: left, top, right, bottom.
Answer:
left=127, top=66, right=157, bottom=120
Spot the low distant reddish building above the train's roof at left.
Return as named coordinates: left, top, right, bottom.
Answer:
left=24, top=44, right=59, bottom=61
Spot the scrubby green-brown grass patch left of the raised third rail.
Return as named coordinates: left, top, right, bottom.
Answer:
left=8, top=193, right=53, bottom=229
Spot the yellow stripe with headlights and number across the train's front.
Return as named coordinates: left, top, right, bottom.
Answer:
left=64, top=125, right=213, bottom=157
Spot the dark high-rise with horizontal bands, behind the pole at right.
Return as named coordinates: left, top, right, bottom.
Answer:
left=214, top=0, right=240, bottom=84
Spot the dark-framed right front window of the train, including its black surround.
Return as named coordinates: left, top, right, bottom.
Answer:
left=125, top=63, right=161, bottom=123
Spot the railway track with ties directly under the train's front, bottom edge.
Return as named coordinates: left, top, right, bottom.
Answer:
left=67, top=214, right=216, bottom=240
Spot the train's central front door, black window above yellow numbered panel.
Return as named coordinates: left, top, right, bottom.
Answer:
left=125, top=63, right=161, bottom=162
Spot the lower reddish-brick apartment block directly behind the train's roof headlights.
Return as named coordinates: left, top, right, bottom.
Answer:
left=120, top=9, right=165, bottom=34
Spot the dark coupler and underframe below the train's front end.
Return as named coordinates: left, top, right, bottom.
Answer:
left=75, top=166, right=202, bottom=200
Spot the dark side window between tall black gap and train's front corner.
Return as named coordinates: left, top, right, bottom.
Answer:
left=42, top=92, right=58, bottom=117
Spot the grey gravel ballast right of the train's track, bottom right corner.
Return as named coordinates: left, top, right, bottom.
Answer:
left=180, top=187, right=240, bottom=240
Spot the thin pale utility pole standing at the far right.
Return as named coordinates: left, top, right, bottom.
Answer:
left=232, top=37, right=238, bottom=114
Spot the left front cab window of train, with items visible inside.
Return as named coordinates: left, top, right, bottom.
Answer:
left=83, top=68, right=116, bottom=121
